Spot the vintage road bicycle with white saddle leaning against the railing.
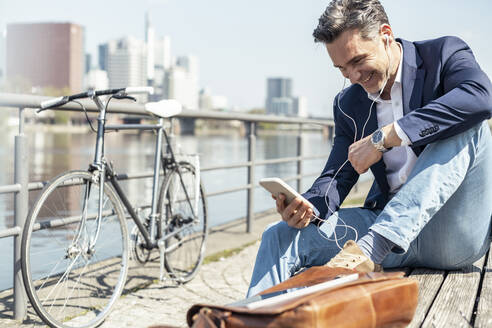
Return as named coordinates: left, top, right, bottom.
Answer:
left=21, top=87, right=208, bottom=327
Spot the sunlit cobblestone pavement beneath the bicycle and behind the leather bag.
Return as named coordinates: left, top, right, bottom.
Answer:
left=0, top=183, right=367, bottom=328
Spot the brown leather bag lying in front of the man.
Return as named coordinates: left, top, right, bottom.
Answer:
left=187, top=266, right=418, bottom=328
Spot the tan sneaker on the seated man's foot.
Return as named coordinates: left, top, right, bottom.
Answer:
left=326, top=240, right=383, bottom=272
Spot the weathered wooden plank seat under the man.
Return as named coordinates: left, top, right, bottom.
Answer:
left=409, top=240, right=492, bottom=327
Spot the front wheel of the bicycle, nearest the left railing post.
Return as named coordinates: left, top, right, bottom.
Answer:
left=22, top=171, right=128, bottom=327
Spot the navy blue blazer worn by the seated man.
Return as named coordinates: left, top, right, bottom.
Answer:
left=303, top=37, right=492, bottom=217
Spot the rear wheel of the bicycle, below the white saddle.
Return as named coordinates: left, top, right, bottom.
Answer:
left=159, top=162, right=208, bottom=283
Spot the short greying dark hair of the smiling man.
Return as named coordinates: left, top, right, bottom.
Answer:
left=313, top=0, right=389, bottom=43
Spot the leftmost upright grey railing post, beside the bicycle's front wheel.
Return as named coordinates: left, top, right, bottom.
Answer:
left=14, top=108, right=29, bottom=320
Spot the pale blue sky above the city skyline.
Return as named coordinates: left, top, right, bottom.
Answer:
left=0, top=0, right=492, bottom=116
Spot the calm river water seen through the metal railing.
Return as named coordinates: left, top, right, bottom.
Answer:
left=0, top=129, right=342, bottom=290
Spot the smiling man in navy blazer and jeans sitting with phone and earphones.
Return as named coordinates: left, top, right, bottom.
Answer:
left=248, top=0, right=492, bottom=296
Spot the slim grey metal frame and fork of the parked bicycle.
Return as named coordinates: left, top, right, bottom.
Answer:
left=86, top=96, right=198, bottom=250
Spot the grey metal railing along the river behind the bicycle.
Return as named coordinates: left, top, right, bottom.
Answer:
left=0, top=93, right=334, bottom=320
